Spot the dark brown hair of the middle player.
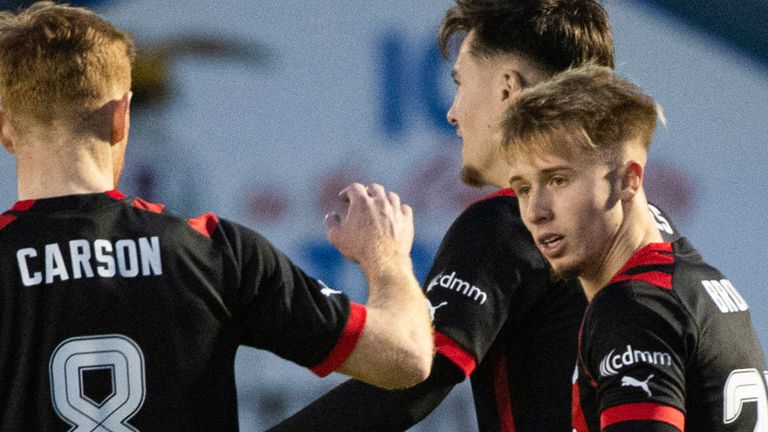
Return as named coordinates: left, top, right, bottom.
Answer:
left=439, top=0, right=614, bottom=73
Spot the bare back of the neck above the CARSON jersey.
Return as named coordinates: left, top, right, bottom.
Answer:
left=16, top=139, right=115, bottom=200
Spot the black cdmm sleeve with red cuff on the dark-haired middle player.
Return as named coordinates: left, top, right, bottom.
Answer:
left=424, top=197, right=548, bottom=378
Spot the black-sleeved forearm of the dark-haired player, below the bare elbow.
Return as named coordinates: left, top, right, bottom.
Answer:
left=269, top=356, right=463, bottom=432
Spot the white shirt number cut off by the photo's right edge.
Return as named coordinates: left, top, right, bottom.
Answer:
left=723, top=369, right=768, bottom=432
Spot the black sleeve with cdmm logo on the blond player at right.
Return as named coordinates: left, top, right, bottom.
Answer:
left=581, top=280, right=696, bottom=431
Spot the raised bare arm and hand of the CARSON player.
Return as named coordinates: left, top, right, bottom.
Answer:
left=325, top=183, right=434, bottom=389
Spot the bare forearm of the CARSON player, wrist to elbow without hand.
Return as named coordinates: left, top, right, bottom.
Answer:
left=339, top=257, right=434, bottom=389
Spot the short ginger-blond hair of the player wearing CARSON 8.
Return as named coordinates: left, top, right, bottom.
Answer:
left=0, top=1, right=135, bottom=128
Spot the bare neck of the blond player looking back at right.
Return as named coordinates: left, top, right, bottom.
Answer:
left=579, top=193, right=663, bottom=301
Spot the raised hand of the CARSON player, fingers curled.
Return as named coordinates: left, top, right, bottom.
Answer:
left=325, top=183, right=413, bottom=274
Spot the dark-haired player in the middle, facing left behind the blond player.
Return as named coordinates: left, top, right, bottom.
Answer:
left=272, top=0, right=676, bottom=432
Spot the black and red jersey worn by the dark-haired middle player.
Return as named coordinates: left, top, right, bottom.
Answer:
left=424, top=189, right=679, bottom=432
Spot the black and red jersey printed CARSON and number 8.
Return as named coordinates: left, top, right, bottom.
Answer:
left=0, top=191, right=365, bottom=431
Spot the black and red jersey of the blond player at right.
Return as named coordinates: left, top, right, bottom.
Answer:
left=574, top=239, right=768, bottom=432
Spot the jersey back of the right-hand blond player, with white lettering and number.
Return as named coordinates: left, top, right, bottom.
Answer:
left=672, top=238, right=768, bottom=432
